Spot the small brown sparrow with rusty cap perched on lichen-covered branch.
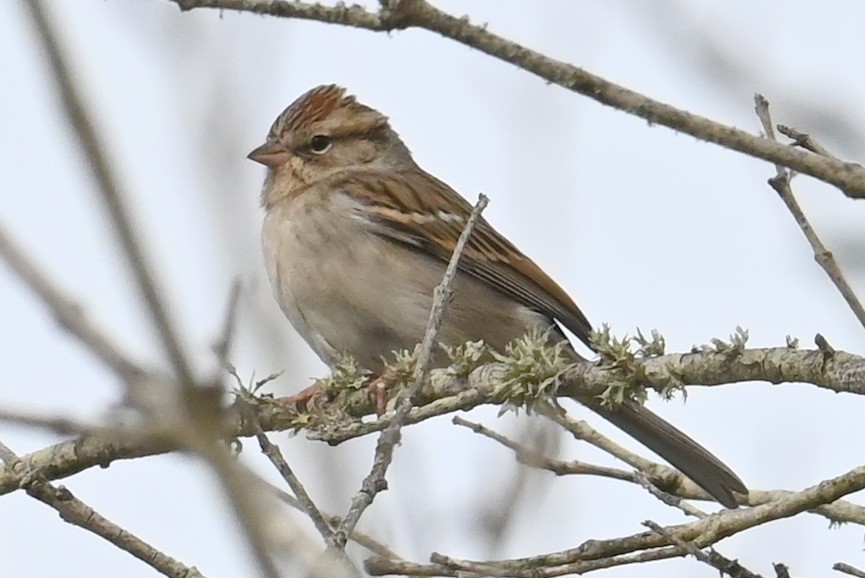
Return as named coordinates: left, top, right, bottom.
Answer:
left=249, top=85, right=747, bottom=507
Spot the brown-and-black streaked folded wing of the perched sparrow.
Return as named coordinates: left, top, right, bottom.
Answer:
left=333, top=170, right=591, bottom=344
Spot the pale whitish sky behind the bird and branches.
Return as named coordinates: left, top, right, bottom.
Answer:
left=0, top=0, right=865, bottom=578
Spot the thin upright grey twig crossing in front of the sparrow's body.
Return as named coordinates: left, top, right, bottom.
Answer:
left=335, top=195, right=489, bottom=548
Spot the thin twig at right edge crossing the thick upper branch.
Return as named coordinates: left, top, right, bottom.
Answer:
left=754, top=94, right=865, bottom=327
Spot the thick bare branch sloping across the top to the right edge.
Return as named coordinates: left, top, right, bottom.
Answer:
left=171, top=0, right=865, bottom=199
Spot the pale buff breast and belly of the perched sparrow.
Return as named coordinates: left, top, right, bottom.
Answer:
left=262, top=191, right=551, bottom=370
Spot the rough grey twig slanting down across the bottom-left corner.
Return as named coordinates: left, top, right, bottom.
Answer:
left=0, top=442, right=204, bottom=578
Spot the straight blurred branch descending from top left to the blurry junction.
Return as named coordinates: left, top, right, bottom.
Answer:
left=21, top=0, right=192, bottom=383
